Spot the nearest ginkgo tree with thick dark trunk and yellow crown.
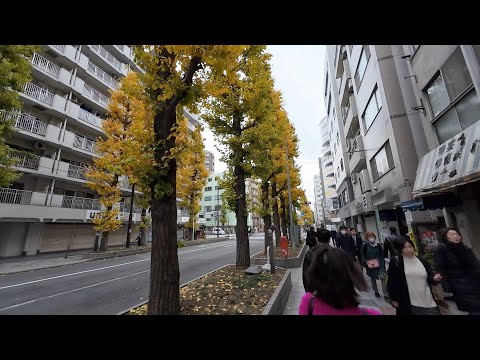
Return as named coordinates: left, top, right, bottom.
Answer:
left=134, top=45, right=245, bottom=315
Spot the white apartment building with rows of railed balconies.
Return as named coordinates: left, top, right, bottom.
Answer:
left=0, top=45, right=146, bottom=257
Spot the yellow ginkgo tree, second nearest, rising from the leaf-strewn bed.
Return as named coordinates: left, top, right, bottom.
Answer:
left=202, top=45, right=273, bottom=269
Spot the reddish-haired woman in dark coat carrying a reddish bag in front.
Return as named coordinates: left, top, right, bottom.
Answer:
left=360, top=232, right=387, bottom=300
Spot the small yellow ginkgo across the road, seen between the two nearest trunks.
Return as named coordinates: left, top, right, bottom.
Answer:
left=176, top=118, right=208, bottom=239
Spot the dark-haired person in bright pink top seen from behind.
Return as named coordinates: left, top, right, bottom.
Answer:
left=298, top=244, right=381, bottom=315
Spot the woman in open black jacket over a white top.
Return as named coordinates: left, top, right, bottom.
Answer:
left=387, top=237, right=442, bottom=315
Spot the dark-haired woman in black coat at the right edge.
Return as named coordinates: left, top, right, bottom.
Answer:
left=434, top=228, right=480, bottom=315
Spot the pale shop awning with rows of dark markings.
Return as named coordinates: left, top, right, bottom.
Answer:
left=412, top=121, right=480, bottom=199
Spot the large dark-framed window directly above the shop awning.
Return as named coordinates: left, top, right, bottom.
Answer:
left=425, top=48, right=480, bottom=143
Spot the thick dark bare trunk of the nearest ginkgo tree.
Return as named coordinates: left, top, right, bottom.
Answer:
left=148, top=106, right=180, bottom=315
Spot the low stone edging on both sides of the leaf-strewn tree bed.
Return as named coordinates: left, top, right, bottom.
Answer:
left=117, top=264, right=292, bottom=315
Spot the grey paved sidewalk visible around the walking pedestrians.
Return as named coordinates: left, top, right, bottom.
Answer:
left=283, top=267, right=467, bottom=315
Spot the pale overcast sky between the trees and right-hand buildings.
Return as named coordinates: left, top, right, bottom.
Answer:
left=203, top=45, right=325, bottom=209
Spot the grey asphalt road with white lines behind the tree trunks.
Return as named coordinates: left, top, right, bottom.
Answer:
left=0, top=236, right=263, bottom=315
